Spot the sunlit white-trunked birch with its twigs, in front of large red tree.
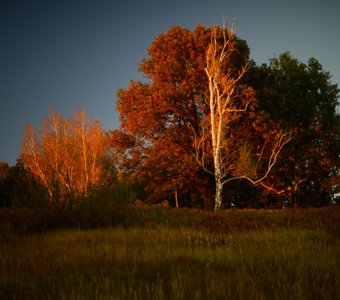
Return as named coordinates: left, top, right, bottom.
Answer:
left=195, top=27, right=291, bottom=210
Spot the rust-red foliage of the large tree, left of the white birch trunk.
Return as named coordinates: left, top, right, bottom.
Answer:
left=112, top=25, right=249, bottom=208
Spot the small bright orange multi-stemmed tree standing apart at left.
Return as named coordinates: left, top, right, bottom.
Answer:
left=20, top=110, right=109, bottom=201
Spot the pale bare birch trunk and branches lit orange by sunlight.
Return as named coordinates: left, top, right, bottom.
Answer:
left=195, top=24, right=291, bottom=210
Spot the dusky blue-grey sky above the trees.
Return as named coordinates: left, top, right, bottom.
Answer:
left=0, top=0, right=340, bottom=165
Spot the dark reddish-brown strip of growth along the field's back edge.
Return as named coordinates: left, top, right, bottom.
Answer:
left=0, top=204, right=340, bottom=234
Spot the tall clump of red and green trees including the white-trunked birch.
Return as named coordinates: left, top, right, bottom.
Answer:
left=111, top=25, right=340, bottom=209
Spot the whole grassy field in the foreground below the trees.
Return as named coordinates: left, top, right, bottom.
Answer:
left=0, top=207, right=340, bottom=299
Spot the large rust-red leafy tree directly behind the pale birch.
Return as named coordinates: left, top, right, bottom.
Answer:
left=112, top=25, right=287, bottom=208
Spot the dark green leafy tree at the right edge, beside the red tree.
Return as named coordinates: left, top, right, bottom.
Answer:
left=251, top=52, right=340, bottom=206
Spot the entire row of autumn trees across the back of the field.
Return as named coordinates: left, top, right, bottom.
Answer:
left=0, top=25, right=340, bottom=209
